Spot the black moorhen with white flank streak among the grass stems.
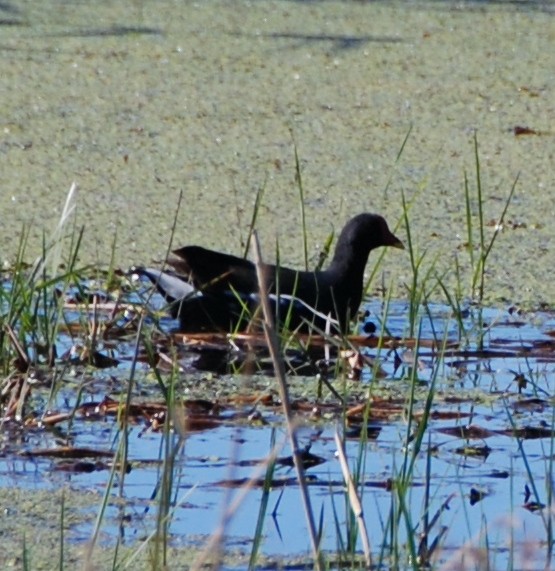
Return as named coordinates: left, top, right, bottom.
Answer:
left=134, top=214, right=404, bottom=332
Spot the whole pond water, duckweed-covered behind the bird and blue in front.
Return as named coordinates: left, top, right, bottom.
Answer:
left=0, top=0, right=555, bottom=569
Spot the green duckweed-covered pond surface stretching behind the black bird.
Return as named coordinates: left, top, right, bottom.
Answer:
left=0, top=0, right=555, bottom=307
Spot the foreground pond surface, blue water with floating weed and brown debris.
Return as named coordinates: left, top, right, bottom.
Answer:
left=0, top=292, right=555, bottom=569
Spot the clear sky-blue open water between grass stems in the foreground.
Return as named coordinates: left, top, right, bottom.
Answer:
left=0, top=302, right=555, bottom=568
